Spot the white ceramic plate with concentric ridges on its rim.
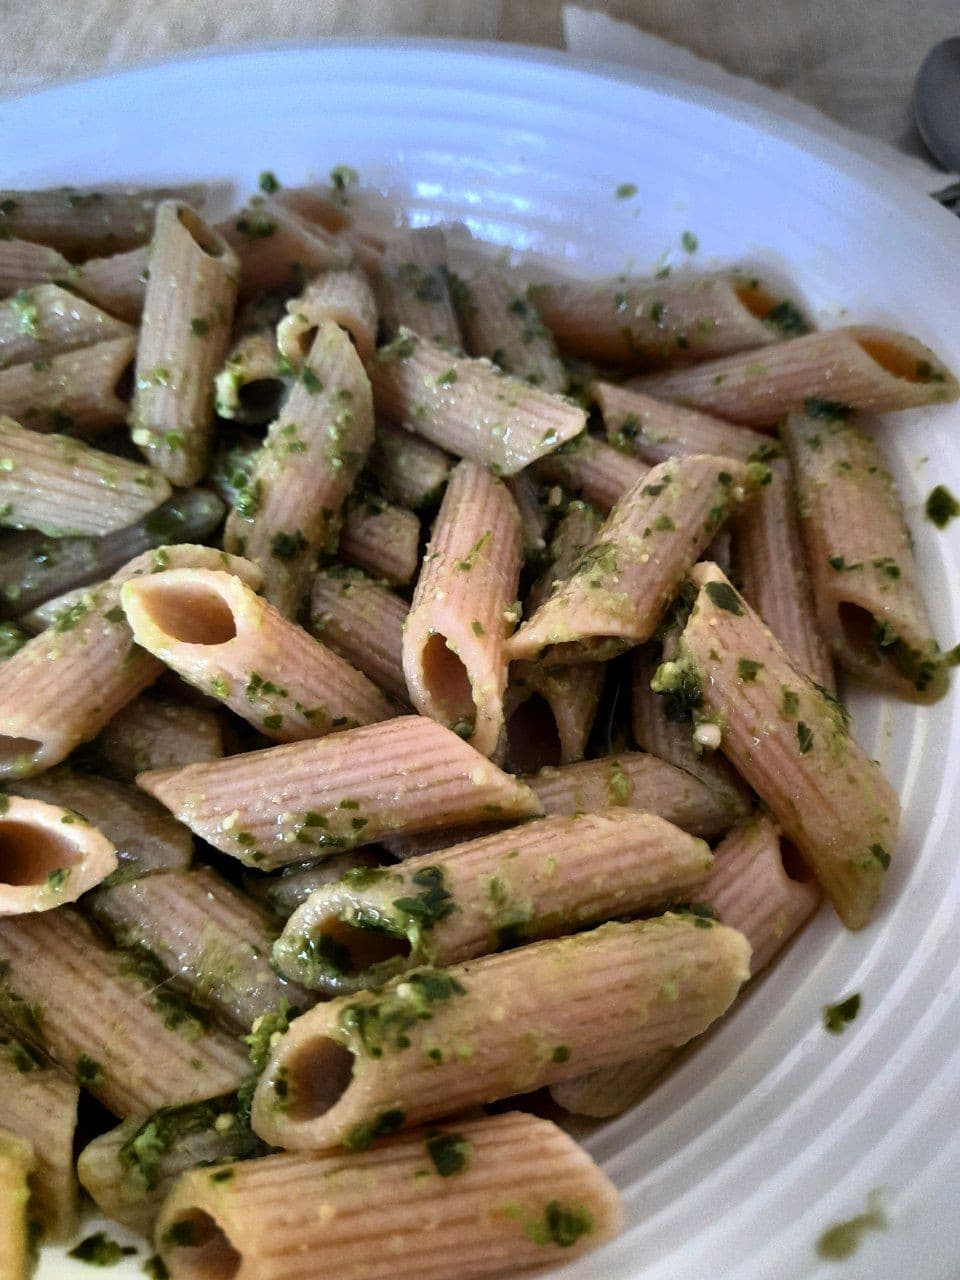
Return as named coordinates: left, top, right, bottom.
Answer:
left=7, top=42, right=960, bottom=1280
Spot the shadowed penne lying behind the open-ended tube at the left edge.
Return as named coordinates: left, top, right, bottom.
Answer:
left=9, top=765, right=193, bottom=883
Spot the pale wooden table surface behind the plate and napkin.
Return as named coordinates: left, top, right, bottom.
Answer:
left=0, top=0, right=960, bottom=150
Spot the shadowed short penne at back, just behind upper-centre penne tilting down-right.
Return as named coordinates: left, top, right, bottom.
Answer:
left=455, top=268, right=567, bottom=392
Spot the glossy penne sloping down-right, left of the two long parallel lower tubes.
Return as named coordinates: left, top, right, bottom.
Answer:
left=84, top=867, right=314, bottom=1032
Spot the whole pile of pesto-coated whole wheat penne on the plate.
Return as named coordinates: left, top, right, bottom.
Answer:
left=0, top=170, right=960, bottom=1280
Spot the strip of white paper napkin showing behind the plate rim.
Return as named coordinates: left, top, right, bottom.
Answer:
left=563, top=5, right=951, bottom=193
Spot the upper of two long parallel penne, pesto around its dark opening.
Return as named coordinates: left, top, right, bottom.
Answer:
left=273, top=808, right=713, bottom=995
